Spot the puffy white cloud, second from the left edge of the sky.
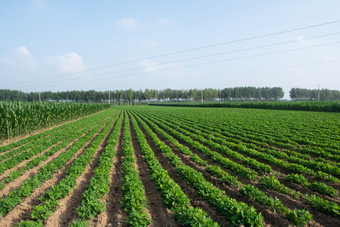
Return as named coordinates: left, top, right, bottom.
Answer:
left=46, top=52, right=86, bottom=73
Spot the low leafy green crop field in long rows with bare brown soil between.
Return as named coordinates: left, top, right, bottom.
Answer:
left=0, top=106, right=340, bottom=226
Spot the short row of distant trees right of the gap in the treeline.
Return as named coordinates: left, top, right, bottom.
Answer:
left=289, top=88, right=340, bottom=101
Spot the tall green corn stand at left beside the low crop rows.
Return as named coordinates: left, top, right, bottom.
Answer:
left=0, top=102, right=108, bottom=141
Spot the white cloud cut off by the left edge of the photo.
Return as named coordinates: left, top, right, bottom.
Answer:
left=1, top=46, right=36, bottom=68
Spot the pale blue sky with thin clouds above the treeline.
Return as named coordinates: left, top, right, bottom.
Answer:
left=0, top=0, right=340, bottom=97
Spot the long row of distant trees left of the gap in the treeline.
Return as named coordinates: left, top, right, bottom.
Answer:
left=0, top=87, right=284, bottom=104
